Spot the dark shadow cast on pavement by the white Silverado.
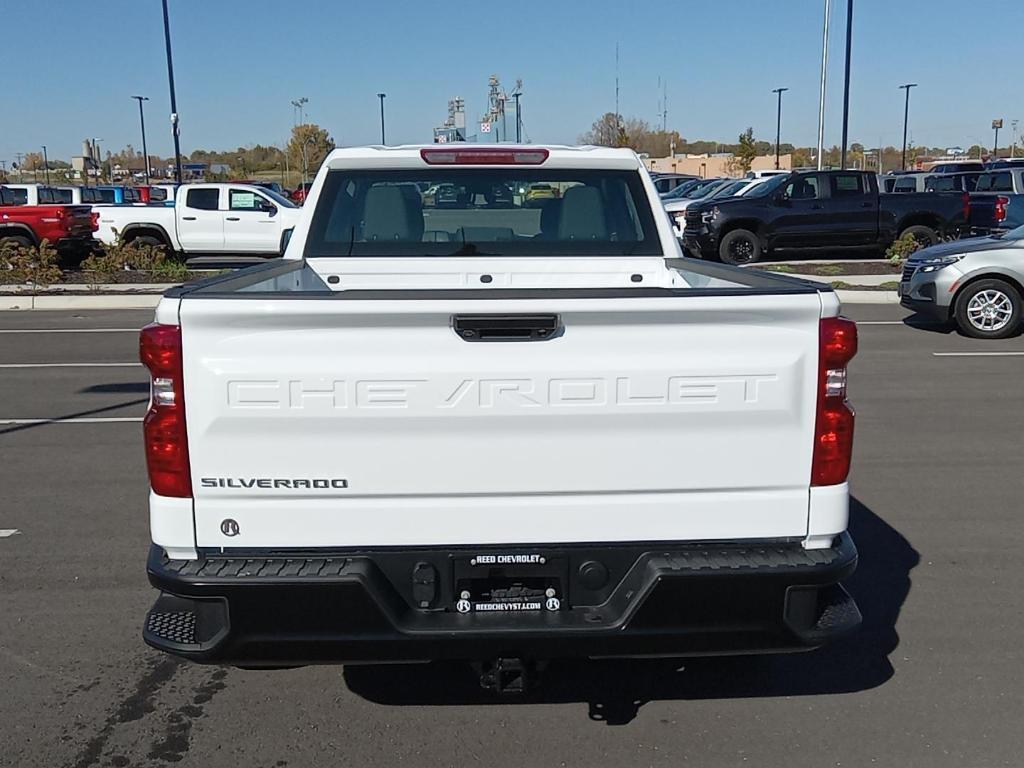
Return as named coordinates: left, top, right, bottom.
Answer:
left=344, top=499, right=920, bottom=725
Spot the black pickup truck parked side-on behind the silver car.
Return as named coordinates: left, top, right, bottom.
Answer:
left=682, top=171, right=970, bottom=264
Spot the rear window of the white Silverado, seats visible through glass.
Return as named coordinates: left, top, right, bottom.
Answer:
left=305, top=168, right=662, bottom=257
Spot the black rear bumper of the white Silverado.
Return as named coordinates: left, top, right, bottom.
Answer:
left=143, top=534, right=860, bottom=666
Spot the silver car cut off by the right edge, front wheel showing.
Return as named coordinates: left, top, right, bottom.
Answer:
left=899, top=226, right=1024, bottom=339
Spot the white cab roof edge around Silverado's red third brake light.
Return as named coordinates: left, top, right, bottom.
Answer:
left=325, top=142, right=642, bottom=170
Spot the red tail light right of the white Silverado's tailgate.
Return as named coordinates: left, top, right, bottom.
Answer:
left=811, top=317, right=857, bottom=485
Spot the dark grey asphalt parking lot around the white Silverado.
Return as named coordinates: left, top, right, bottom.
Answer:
left=0, top=306, right=1024, bottom=768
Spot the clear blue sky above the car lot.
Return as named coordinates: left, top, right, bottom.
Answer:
left=0, top=0, right=1024, bottom=164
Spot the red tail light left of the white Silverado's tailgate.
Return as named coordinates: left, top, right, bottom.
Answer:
left=139, top=323, right=191, bottom=499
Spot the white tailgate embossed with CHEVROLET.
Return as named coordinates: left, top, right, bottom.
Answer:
left=179, top=292, right=821, bottom=549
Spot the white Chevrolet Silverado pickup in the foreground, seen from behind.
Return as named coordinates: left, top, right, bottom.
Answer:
left=140, top=145, right=860, bottom=688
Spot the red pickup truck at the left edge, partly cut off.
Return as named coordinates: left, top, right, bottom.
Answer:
left=0, top=186, right=99, bottom=255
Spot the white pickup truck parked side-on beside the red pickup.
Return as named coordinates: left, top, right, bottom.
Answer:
left=96, top=184, right=301, bottom=256
